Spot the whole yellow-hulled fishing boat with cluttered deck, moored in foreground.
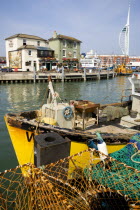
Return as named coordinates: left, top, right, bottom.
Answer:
left=5, top=74, right=140, bottom=165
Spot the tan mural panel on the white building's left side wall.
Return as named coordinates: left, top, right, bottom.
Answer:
left=9, top=50, right=22, bottom=69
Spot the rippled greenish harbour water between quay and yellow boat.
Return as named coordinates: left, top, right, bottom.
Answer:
left=0, top=77, right=131, bottom=172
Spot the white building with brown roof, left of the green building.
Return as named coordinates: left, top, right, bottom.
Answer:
left=5, top=34, right=56, bottom=71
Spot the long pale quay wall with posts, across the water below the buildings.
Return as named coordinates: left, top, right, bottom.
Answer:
left=0, top=71, right=117, bottom=84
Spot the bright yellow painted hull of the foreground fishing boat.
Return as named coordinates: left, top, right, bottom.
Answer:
left=5, top=119, right=125, bottom=165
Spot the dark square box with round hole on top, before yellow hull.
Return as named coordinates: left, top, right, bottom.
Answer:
left=34, top=132, right=71, bottom=167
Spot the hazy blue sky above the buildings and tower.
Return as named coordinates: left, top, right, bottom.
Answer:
left=0, top=0, right=140, bottom=56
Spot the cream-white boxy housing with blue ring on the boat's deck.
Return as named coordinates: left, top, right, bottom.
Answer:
left=41, top=103, right=74, bottom=129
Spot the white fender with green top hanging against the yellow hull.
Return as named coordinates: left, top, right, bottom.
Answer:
left=96, top=132, right=108, bottom=160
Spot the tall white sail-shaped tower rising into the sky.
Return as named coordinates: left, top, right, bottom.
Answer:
left=119, top=5, right=130, bottom=56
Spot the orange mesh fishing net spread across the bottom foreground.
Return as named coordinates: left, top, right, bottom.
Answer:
left=0, top=148, right=140, bottom=210
